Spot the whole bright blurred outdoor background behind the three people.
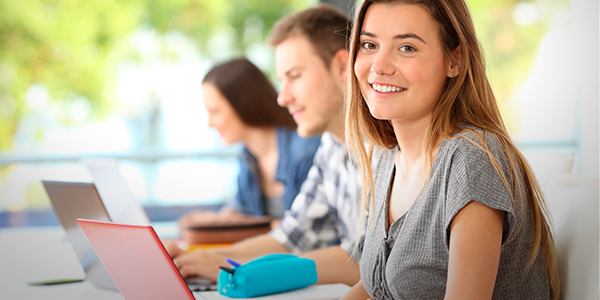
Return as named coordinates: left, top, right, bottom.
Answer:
left=0, top=0, right=599, bottom=227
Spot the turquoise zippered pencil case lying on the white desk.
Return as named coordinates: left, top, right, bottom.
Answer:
left=217, top=254, right=317, bottom=298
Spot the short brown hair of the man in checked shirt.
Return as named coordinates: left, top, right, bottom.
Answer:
left=268, top=4, right=352, bottom=68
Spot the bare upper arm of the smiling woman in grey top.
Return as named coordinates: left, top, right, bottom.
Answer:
left=444, top=201, right=504, bottom=300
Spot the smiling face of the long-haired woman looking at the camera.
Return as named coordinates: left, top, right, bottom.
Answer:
left=354, top=4, right=458, bottom=124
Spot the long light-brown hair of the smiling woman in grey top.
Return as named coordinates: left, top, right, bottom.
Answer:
left=345, top=0, right=560, bottom=299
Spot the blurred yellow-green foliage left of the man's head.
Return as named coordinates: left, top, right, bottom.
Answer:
left=0, top=0, right=313, bottom=150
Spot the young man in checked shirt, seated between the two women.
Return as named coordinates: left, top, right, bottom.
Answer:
left=168, top=5, right=360, bottom=285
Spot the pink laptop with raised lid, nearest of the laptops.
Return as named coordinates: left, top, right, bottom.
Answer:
left=77, top=219, right=194, bottom=300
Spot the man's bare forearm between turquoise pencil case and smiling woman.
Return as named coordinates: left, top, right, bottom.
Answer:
left=301, top=246, right=360, bottom=286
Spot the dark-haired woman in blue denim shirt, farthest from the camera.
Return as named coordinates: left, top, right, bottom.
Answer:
left=180, top=58, right=320, bottom=226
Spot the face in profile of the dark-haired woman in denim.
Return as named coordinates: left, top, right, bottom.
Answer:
left=202, top=83, right=248, bottom=145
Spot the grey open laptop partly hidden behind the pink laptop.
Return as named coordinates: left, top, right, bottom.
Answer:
left=42, top=180, right=216, bottom=290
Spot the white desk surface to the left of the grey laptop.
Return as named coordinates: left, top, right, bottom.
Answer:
left=0, top=227, right=123, bottom=300
